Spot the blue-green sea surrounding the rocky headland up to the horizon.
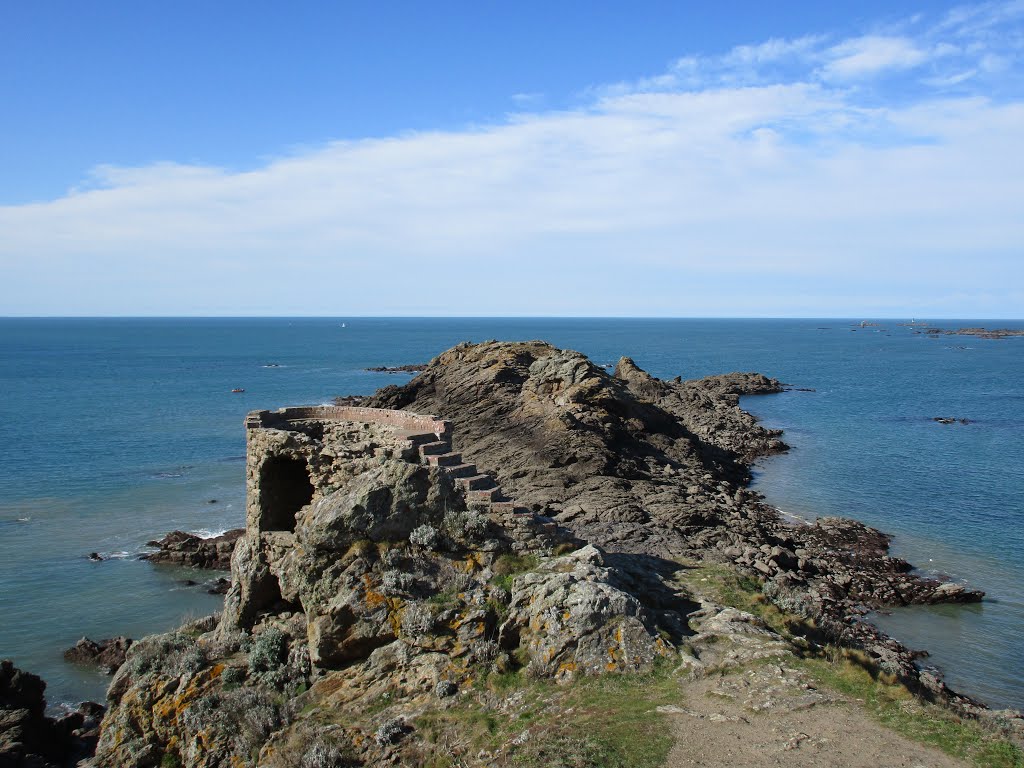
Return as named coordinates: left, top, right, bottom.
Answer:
left=0, top=317, right=1024, bottom=708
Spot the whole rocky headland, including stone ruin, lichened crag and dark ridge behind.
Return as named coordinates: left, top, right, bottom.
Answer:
left=12, top=341, right=1019, bottom=768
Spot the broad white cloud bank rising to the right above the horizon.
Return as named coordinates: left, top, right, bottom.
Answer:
left=0, top=3, right=1024, bottom=314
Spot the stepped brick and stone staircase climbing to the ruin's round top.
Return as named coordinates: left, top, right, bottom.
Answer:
left=408, top=432, right=568, bottom=549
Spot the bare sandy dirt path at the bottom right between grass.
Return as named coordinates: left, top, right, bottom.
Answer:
left=658, top=664, right=968, bottom=768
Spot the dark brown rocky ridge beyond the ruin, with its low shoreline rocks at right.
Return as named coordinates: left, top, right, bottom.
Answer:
left=366, top=342, right=982, bottom=704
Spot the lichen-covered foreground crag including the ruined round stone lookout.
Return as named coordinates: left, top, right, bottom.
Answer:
left=96, top=399, right=691, bottom=768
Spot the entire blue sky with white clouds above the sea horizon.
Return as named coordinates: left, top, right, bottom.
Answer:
left=0, top=0, right=1024, bottom=317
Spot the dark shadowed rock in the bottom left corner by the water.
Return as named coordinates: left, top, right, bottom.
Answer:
left=0, top=659, right=102, bottom=768
